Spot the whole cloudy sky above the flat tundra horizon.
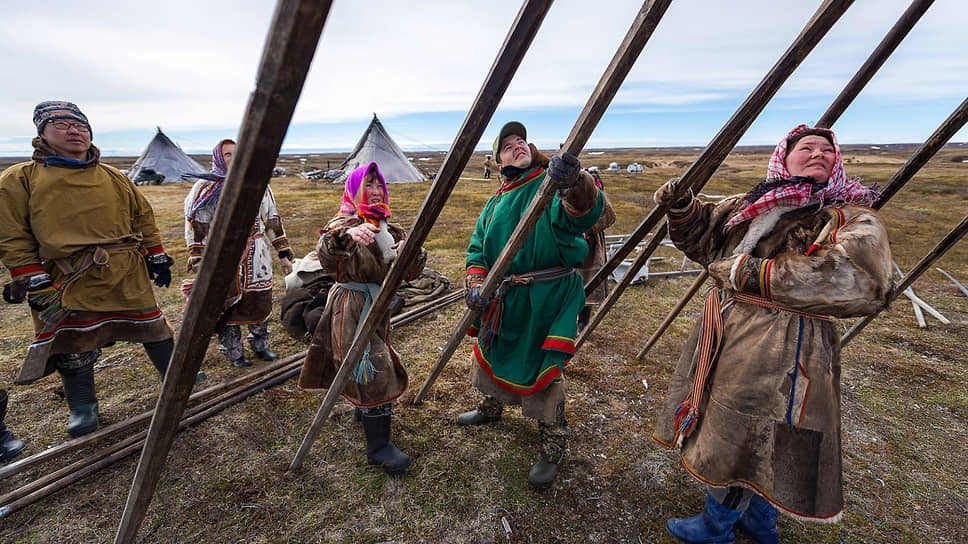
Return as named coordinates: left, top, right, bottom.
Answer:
left=0, top=0, right=968, bottom=156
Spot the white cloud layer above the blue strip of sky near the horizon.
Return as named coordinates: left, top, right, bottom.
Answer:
left=0, top=0, right=968, bottom=149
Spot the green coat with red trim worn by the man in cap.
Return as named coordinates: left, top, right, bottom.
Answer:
left=466, top=167, right=604, bottom=395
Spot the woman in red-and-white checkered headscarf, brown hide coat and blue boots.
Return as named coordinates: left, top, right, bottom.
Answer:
left=653, top=125, right=893, bottom=543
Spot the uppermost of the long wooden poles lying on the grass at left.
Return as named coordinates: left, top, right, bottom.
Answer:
left=0, top=351, right=306, bottom=479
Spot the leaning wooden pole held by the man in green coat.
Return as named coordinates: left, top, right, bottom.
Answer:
left=413, top=0, right=671, bottom=404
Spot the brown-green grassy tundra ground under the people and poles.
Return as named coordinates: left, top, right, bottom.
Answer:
left=0, top=148, right=968, bottom=544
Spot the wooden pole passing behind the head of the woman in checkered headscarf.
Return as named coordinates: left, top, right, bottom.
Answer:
left=635, top=0, right=934, bottom=359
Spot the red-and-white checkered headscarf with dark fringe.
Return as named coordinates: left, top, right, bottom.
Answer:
left=725, top=125, right=880, bottom=230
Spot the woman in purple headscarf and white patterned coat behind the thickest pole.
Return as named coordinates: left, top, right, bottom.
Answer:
left=185, top=140, right=294, bottom=367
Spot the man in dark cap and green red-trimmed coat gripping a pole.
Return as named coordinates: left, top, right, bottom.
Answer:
left=457, top=121, right=604, bottom=488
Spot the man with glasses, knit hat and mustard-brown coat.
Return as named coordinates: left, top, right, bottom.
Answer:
left=0, top=101, right=174, bottom=436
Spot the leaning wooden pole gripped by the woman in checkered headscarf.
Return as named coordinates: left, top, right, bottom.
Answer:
left=585, top=0, right=853, bottom=293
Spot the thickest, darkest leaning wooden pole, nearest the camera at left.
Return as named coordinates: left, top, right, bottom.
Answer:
left=115, top=0, right=331, bottom=543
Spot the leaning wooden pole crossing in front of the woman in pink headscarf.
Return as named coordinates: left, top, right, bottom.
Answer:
left=289, top=0, right=551, bottom=470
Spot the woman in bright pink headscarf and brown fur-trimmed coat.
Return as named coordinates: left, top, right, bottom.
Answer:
left=299, top=162, right=427, bottom=474
